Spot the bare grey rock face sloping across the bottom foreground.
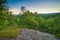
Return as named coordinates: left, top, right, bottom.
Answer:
left=16, top=29, right=58, bottom=40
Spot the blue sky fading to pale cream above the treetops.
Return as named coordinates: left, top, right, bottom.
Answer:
left=8, top=0, right=60, bottom=14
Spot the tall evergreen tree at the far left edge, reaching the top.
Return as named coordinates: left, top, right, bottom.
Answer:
left=0, top=0, right=8, bottom=28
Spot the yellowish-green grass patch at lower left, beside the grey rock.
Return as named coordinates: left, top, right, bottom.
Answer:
left=0, top=27, right=19, bottom=37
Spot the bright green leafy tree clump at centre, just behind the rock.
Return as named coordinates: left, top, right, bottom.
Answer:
left=20, top=12, right=37, bottom=29
